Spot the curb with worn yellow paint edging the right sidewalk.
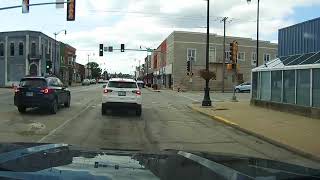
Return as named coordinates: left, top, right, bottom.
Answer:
left=188, top=105, right=320, bottom=162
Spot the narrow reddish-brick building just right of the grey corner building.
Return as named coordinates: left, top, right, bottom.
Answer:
left=59, top=43, right=77, bottom=85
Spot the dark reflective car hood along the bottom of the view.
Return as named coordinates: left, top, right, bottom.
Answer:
left=0, top=143, right=320, bottom=180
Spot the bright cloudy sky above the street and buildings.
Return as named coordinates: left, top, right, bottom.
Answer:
left=0, top=0, right=320, bottom=73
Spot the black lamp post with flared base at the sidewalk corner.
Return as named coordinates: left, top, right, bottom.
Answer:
left=202, top=0, right=211, bottom=106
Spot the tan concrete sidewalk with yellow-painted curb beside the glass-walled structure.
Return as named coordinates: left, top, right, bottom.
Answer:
left=190, top=102, right=320, bottom=161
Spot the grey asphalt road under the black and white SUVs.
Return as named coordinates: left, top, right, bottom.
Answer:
left=0, top=85, right=320, bottom=168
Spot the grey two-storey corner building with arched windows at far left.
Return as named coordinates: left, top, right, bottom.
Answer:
left=0, top=31, right=60, bottom=87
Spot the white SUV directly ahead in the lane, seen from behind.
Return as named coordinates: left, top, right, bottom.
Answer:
left=101, top=78, right=142, bottom=116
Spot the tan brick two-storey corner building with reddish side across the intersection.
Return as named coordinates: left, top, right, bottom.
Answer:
left=151, top=31, right=278, bottom=90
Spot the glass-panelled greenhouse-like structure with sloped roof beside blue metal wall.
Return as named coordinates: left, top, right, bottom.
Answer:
left=251, top=52, right=320, bottom=109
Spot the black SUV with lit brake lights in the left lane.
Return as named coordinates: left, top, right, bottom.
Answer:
left=14, top=77, right=71, bottom=114
